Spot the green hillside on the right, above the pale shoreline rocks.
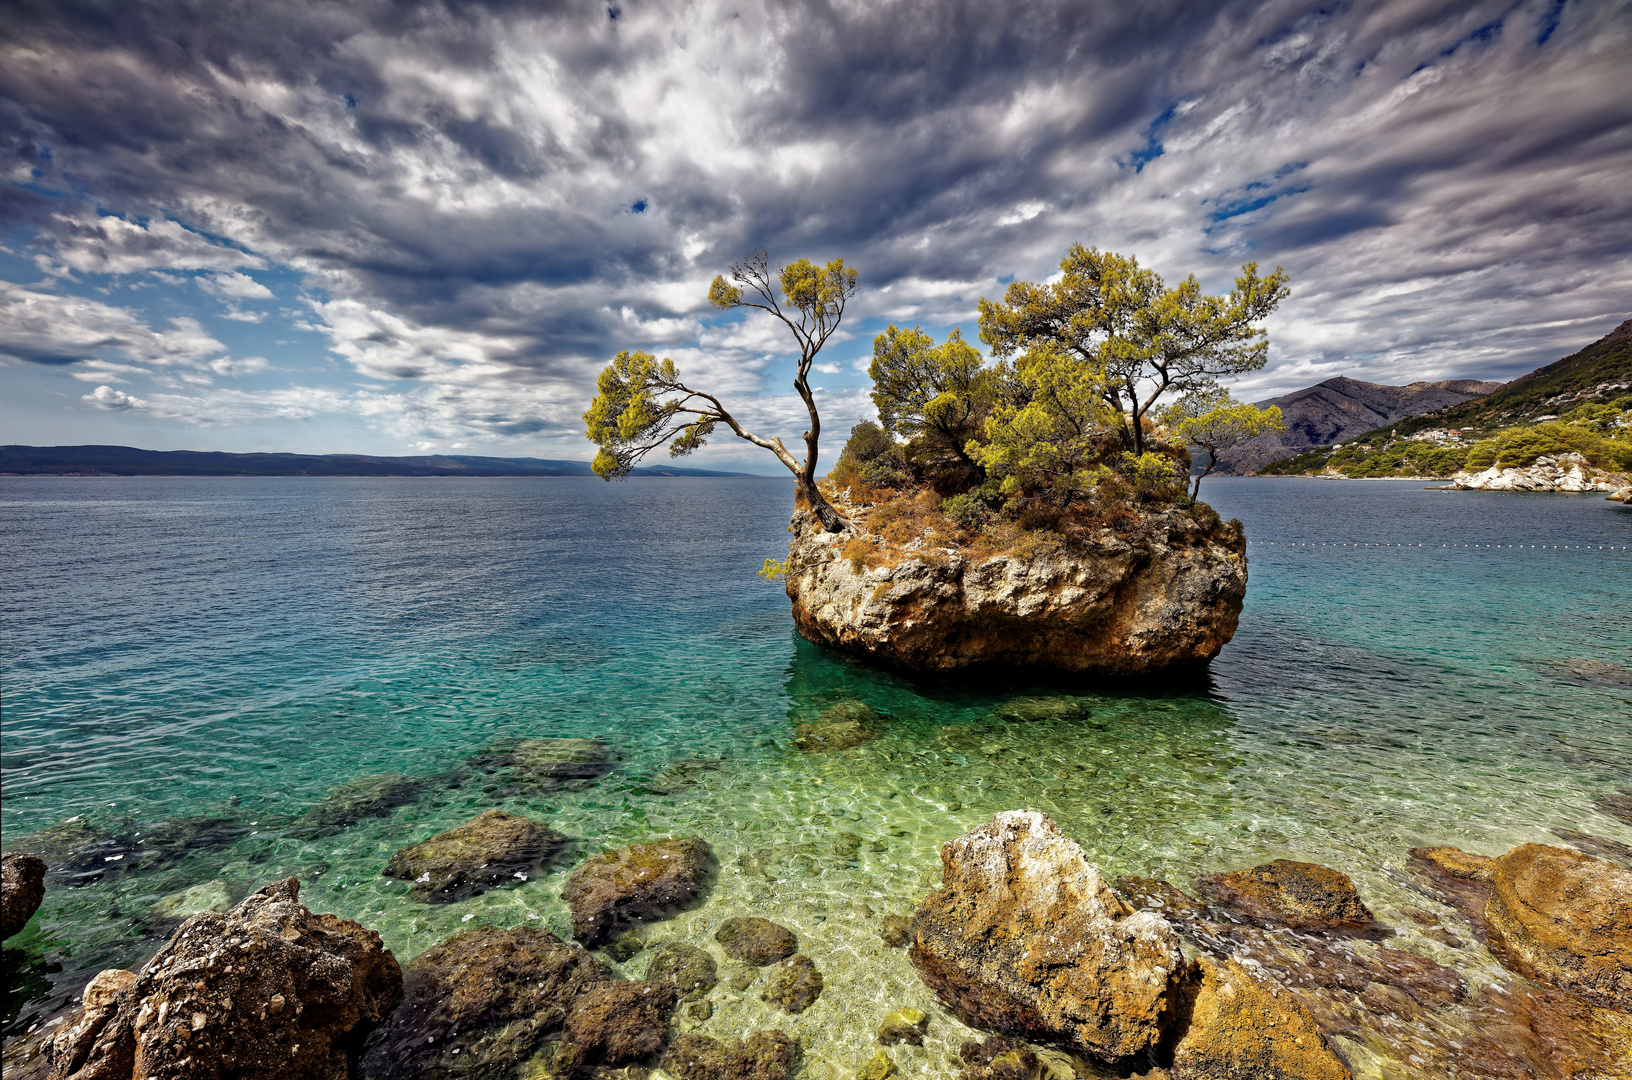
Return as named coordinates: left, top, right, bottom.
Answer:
left=1258, top=318, right=1632, bottom=476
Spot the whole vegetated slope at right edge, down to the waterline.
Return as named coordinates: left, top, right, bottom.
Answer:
left=1258, top=320, right=1632, bottom=478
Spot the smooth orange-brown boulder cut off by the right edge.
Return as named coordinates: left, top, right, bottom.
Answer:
left=1485, top=843, right=1632, bottom=1011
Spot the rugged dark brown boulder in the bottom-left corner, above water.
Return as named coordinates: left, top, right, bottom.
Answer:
left=52, top=878, right=403, bottom=1080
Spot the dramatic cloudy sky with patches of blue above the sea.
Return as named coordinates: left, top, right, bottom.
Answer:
left=0, top=0, right=1632, bottom=471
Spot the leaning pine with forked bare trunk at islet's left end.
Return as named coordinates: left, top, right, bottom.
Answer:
left=584, top=251, right=855, bottom=532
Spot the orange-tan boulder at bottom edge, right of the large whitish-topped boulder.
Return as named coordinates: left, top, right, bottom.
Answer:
left=1172, top=958, right=1350, bottom=1080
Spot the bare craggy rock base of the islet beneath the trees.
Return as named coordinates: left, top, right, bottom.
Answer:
left=787, top=507, right=1247, bottom=677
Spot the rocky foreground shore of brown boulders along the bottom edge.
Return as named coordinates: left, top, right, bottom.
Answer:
left=5, top=811, right=1632, bottom=1080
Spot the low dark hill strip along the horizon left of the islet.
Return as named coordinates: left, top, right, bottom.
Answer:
left=0, top=445, right=752, bottom=476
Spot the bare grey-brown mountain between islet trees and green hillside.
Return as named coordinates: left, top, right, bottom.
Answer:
left=1219, top=377, right=1503, bottom=473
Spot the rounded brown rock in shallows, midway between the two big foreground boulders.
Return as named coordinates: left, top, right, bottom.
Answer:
left=561, top=837, right=710, bottom=948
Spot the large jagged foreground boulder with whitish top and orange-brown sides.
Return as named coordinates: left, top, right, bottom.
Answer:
left=909, top=811, right=1183, bottom=1060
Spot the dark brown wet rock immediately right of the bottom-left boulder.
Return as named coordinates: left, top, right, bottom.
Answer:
left=361, top=927, right=612, bottom=1080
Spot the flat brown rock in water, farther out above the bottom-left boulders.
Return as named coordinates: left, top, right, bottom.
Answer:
left=380, top=811, right=566, bottom=904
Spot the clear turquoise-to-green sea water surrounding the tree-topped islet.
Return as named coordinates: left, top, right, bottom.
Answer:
left=0, top=478, right=1632, bottom=1077
